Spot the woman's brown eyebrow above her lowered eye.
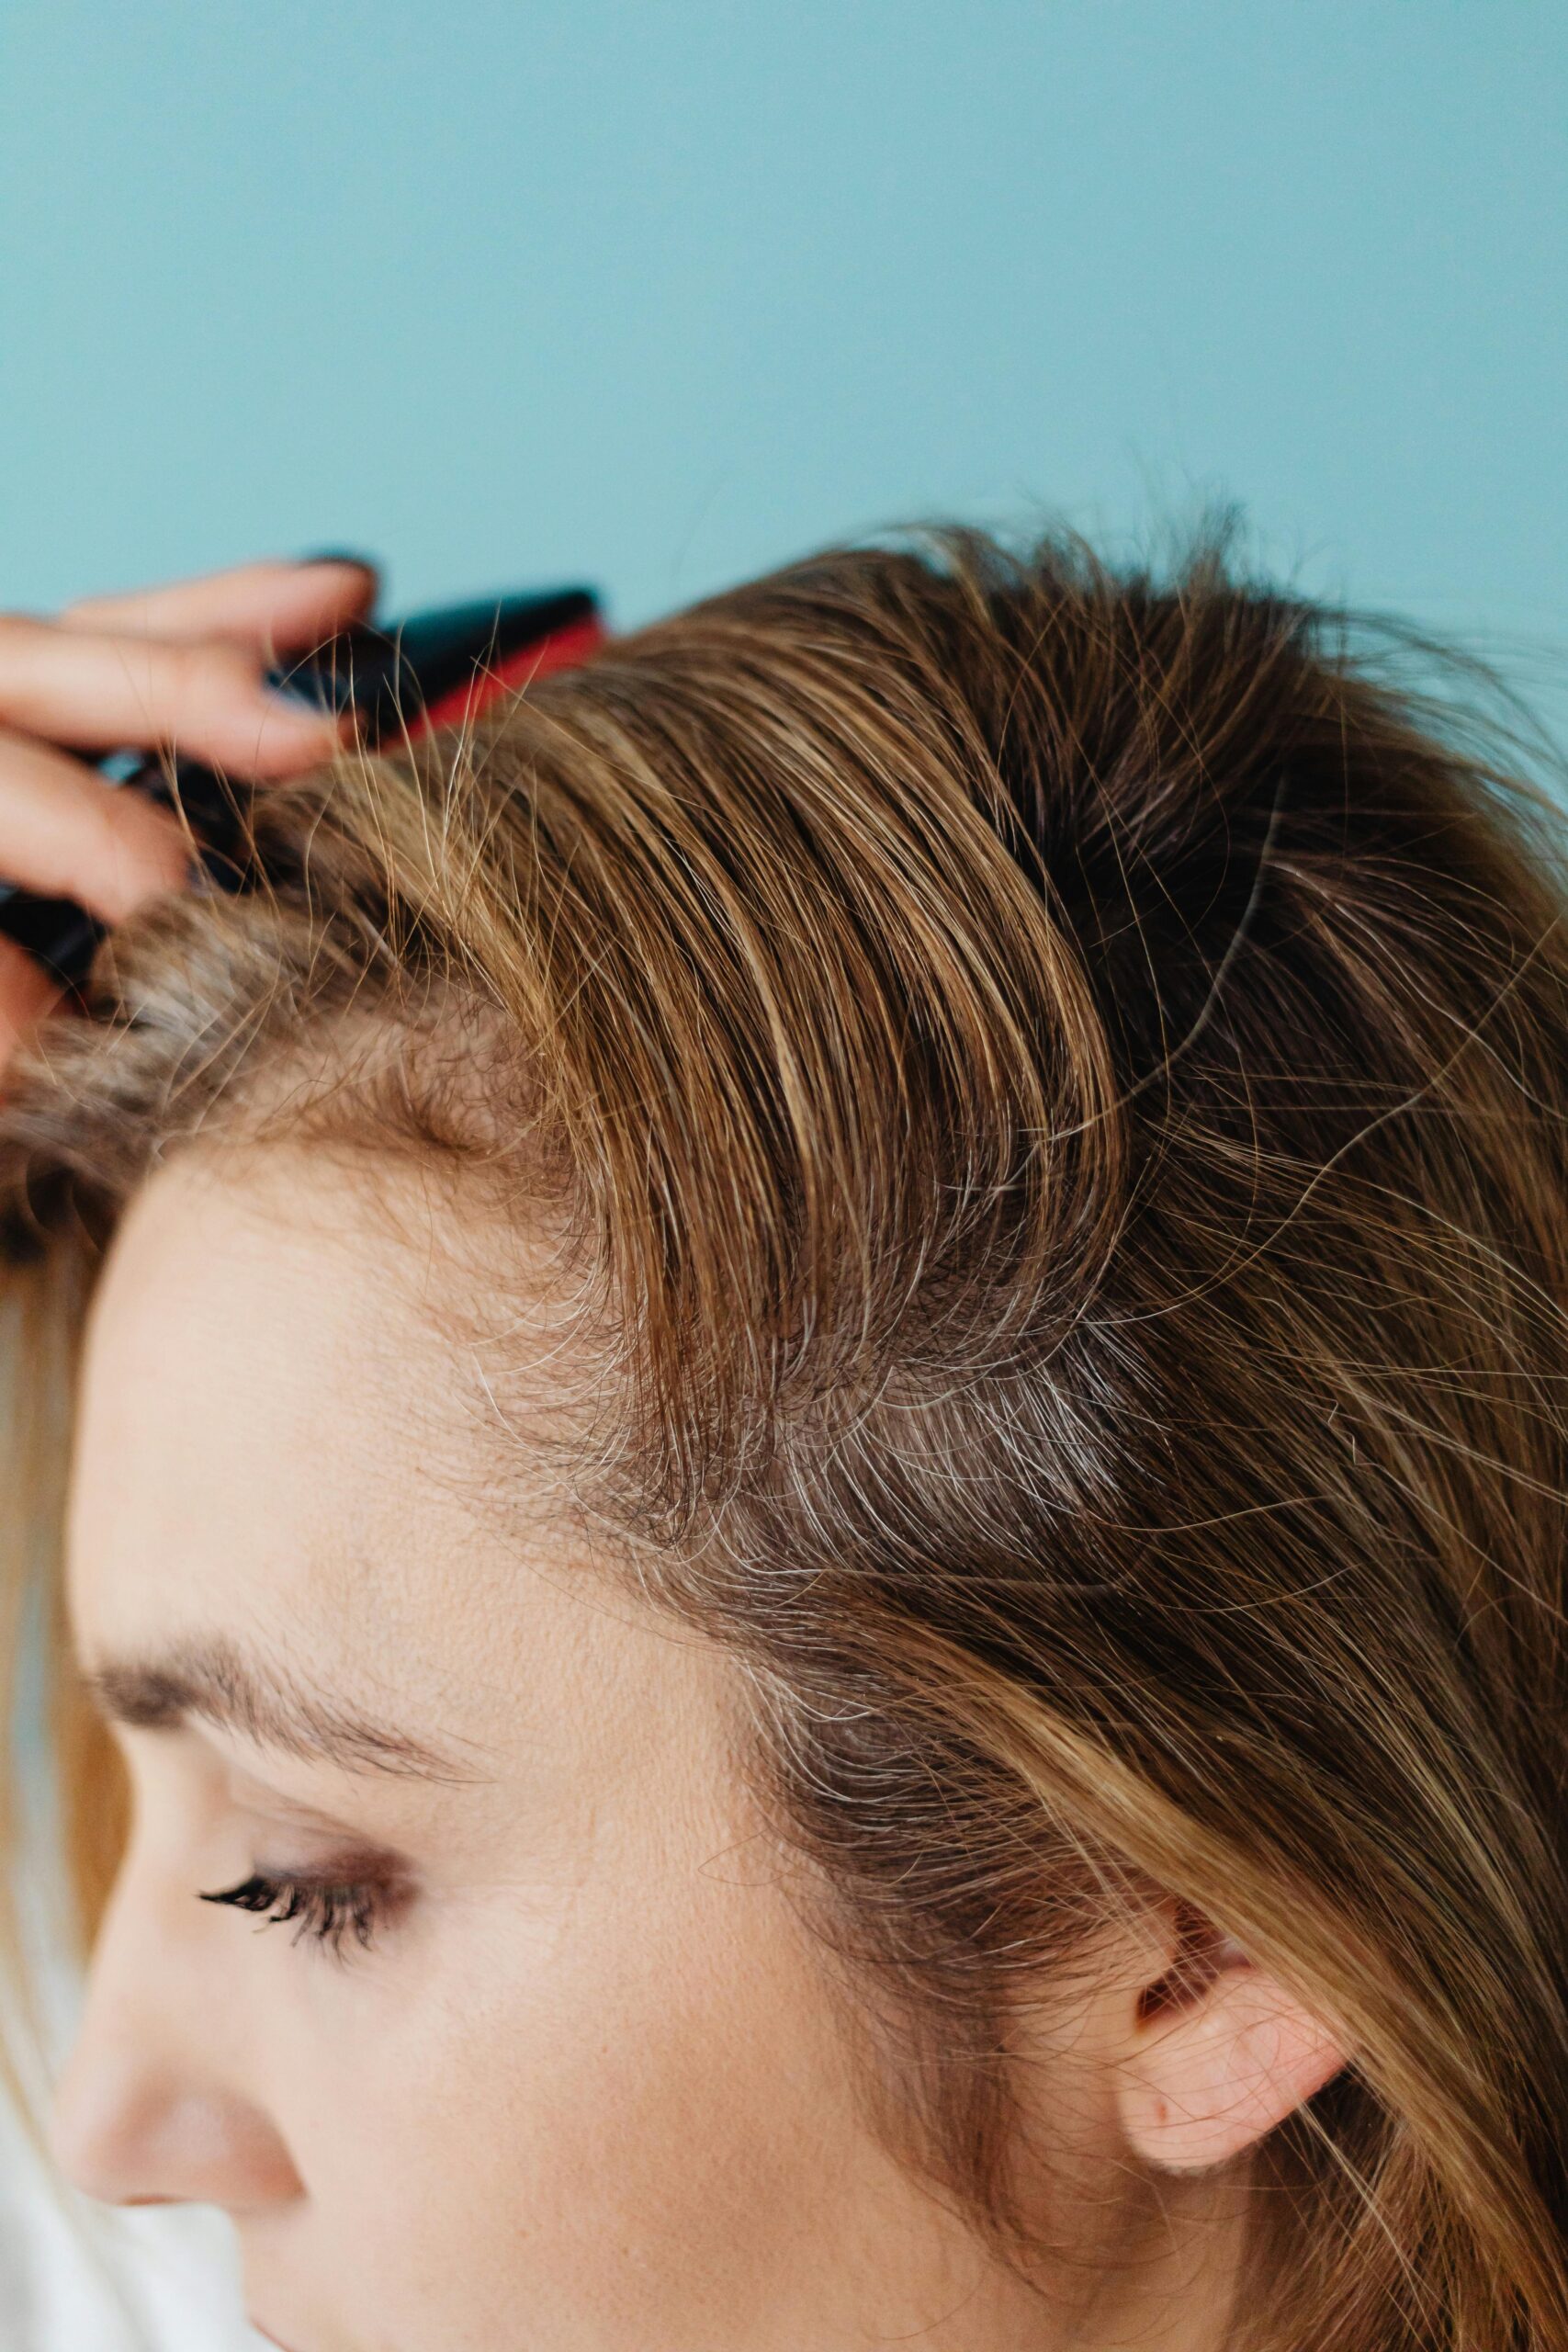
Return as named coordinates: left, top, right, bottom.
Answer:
left=80, top=1634, right=484, bottom=1781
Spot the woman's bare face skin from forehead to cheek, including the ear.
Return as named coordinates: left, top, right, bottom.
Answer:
left=12, top=560, right=1340, bottom=2352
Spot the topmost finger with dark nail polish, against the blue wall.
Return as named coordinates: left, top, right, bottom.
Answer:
left=59, top=555, right=381, bottom=651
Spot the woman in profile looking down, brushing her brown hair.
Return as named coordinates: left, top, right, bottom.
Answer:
left=0, top=532, right=1568, bottom=2352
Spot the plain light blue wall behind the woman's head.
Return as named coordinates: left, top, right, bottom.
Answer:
left=0, top=0, right=1568, bottom=642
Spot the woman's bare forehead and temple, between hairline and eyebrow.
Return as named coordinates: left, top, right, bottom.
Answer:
left=66, top=1155, right=757, bottom=1820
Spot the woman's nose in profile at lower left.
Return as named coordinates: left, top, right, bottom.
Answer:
left=50, top=1874, right=303, bottom=2213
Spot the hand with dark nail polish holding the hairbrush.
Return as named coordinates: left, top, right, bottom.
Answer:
left=0, top=558, right=376, bottom=1066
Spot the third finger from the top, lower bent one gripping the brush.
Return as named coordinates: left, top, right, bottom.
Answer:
left=0, top=734, right=190, bottom=922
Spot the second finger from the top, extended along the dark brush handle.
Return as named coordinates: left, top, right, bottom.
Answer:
left=0, top=614, right=353, bottom=776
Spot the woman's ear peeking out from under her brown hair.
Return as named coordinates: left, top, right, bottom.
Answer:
left=1117, top=1903, right=1345, bottom=2173
